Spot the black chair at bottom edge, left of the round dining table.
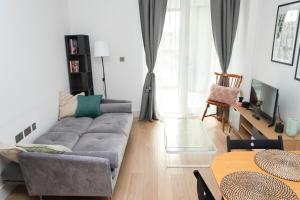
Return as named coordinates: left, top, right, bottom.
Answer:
left=194, top=170, right=223, bottom=200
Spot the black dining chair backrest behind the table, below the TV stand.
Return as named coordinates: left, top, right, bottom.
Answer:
left=227, top=136, right=283, bottom=152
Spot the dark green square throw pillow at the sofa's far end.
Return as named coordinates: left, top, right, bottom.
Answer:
left=75, top=95, right=102, bottom=118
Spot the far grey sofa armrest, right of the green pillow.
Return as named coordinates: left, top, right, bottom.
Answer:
left=100, top=103, right=132, bottom=113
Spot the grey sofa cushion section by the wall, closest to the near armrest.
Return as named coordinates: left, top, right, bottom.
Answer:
left=34, top=132, right=79, bottom=149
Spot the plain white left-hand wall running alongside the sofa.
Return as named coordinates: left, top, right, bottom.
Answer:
left=0, top=0, right=69, bottom=199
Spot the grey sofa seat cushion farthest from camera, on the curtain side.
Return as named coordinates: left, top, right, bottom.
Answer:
left=87, top=113, right=133, bottom=136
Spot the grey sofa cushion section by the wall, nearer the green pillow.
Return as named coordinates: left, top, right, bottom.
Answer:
left=49, top=117, right=93, bottom=135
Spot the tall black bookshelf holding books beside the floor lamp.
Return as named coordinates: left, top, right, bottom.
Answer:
left=65, top=35, right=94, bottom=95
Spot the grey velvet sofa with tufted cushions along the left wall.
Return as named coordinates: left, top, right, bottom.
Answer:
left=2, top=100, right=133, bottom=197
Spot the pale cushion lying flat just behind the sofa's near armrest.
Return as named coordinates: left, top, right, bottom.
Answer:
left=16, top=144, right=71, bottom=154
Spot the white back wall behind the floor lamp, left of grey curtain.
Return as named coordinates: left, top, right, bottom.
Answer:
left=69, top=0, right=144, bottom=112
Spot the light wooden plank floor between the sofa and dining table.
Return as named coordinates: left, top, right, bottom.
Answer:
left=6, top=118, right=232, bottom=200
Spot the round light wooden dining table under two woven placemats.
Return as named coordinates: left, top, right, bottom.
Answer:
left=211, top=151, right=300, bottom=199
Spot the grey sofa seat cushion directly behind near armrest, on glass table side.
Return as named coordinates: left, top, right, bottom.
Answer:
left=73, top=133, right=127, bottom=168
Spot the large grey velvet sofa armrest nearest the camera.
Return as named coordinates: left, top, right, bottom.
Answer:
left=19, top=152, right=112, bottom=196
